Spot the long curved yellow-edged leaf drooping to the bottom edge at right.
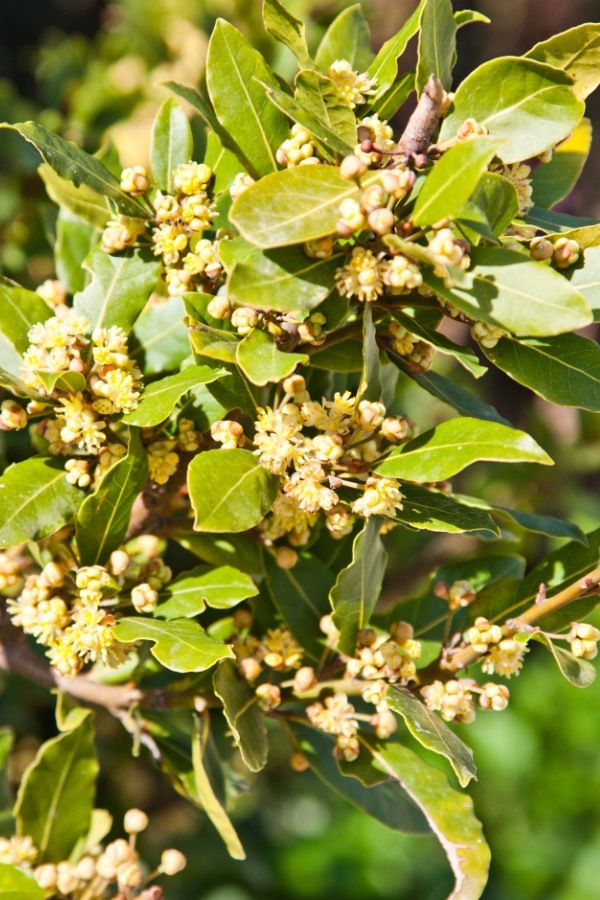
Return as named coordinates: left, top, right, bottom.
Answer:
left=342, top=734, right=490, bottom=900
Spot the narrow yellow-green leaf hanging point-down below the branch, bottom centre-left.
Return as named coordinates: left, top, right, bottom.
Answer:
left=192, top=717, right=246, bottom=859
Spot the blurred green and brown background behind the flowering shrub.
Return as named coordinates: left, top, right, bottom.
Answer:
left=0, top=0, right=600, bottom=900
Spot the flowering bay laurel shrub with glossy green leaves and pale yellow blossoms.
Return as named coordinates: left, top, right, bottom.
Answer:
left=0, top=0, right=600, bottom=900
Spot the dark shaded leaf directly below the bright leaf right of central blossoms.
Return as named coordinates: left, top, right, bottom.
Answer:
left=396, top=484, right=499, bottom=536
